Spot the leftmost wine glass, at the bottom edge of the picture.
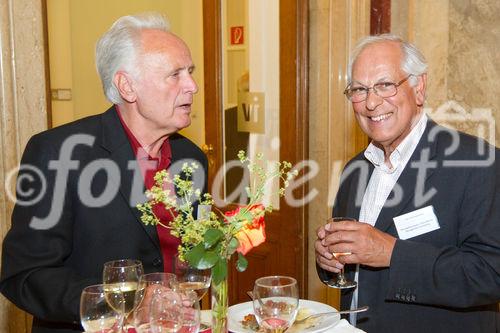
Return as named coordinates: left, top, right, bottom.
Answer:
left=80, top=284, right=124, bottom=333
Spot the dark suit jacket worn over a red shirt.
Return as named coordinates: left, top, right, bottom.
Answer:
left=0, top=107, right=207, bottom=333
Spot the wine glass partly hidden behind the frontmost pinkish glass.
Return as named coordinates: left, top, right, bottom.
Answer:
left=134, top=272, right=177, bottom=333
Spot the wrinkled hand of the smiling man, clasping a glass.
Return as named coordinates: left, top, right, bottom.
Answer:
left=315, top=221, right=396, bottom=272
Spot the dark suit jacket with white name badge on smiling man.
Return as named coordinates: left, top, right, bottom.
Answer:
left=318, top=121, right=500, bottom=333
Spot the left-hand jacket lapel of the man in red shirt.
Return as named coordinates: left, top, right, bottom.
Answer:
left=97, top=107, right=160, bottom=249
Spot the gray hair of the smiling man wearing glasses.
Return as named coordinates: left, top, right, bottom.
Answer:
left=347, top=34, right=428, bottom=86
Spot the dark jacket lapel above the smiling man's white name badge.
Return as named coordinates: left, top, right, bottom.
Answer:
left=375, top=119, right=437, bottom=231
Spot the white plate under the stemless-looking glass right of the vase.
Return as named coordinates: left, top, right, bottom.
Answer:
left=227, top=299, right=340, bottom=333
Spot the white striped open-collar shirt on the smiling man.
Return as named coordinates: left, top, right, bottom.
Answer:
left=350, top=113, right=427, bottom=325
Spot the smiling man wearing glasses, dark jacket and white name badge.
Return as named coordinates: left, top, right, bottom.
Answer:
left=315, top=35, right=500, bottom=333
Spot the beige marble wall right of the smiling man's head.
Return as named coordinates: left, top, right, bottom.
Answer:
left=391, top=0, right=500, bottom=146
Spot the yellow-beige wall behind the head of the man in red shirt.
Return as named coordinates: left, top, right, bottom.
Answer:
left=47, top=0, right=205, bottom=145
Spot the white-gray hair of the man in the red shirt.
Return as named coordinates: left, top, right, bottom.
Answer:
left=95, top=13, right=170, bottom=104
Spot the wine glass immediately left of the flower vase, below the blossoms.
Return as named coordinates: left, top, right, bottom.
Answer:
left=174, top=256, right=212, bottom=300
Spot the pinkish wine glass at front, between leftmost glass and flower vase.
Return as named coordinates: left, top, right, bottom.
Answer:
left=149, top=289, right=201, bottom=333
